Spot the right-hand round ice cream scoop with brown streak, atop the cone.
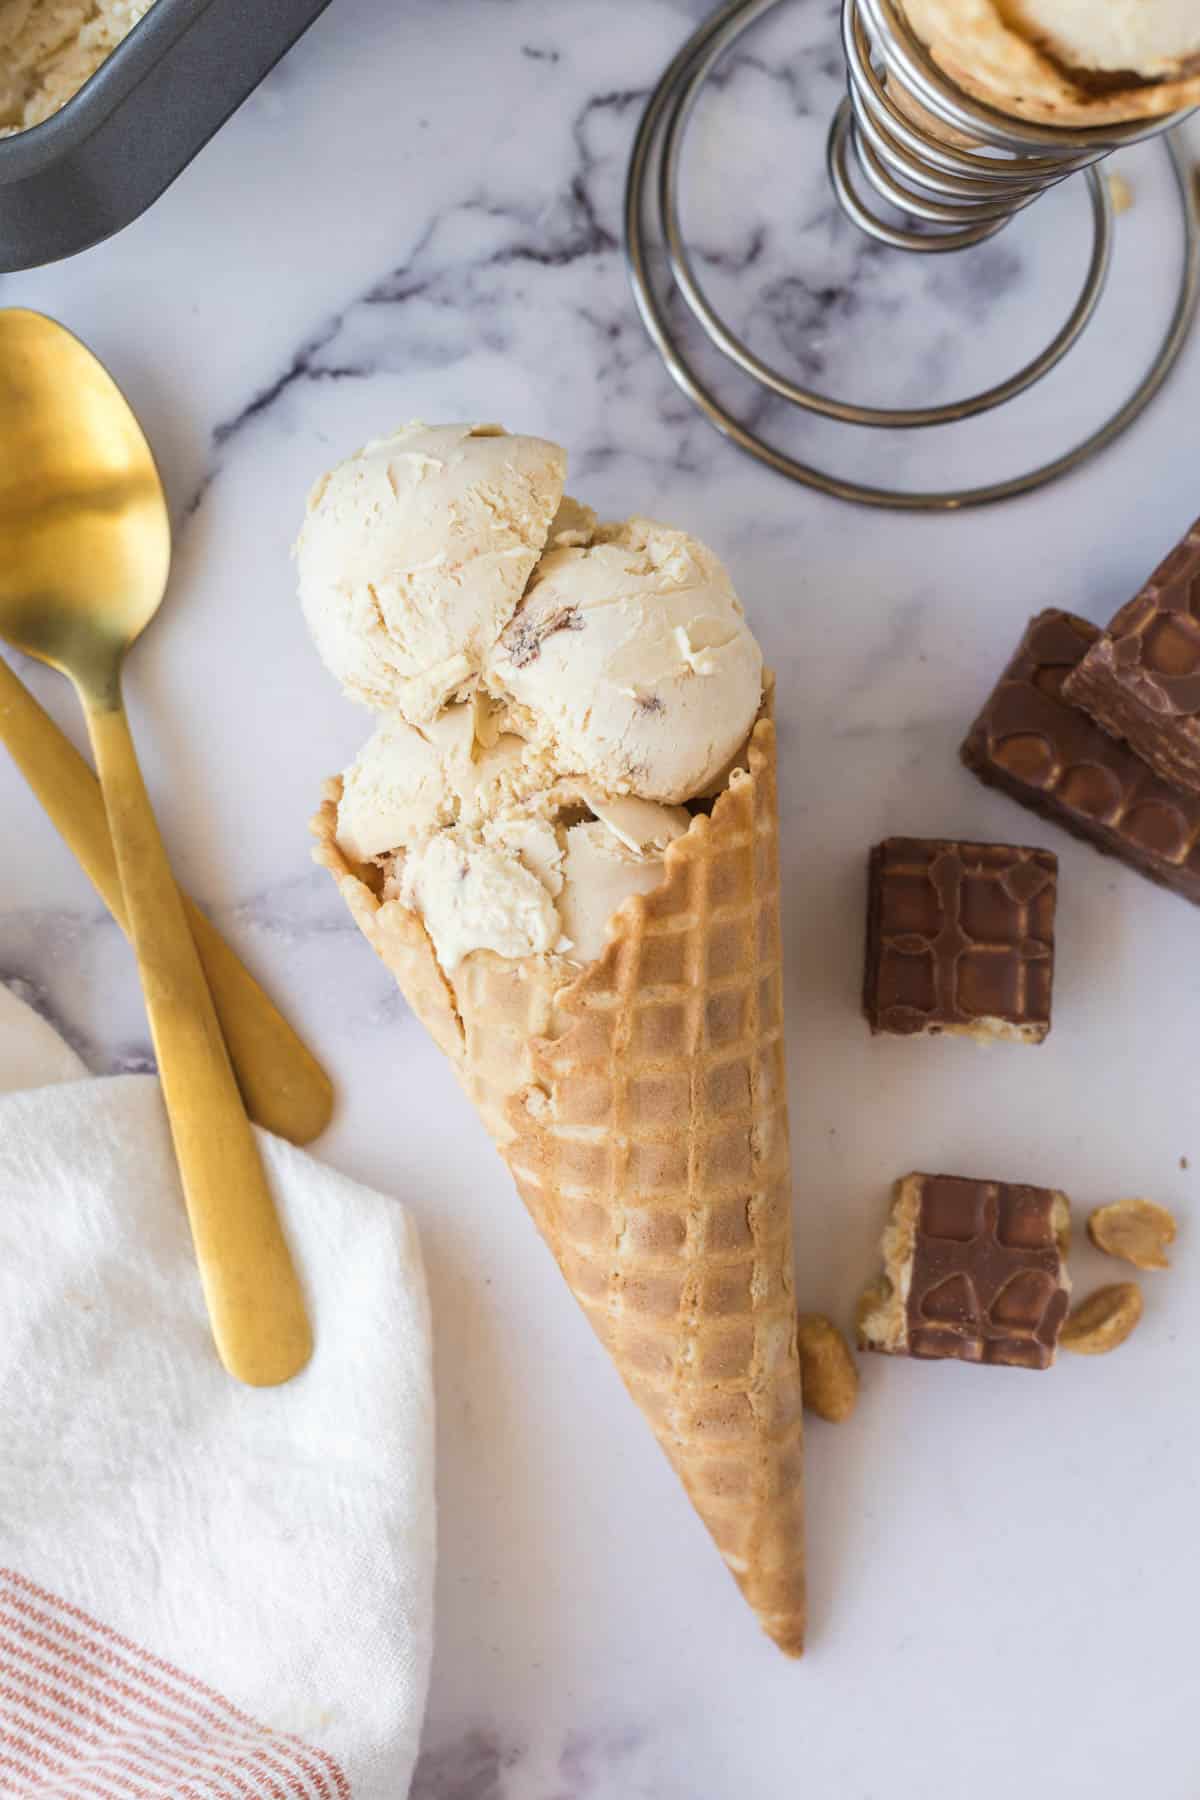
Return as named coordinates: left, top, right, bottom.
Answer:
left=484, top=518, right=763, bottom=801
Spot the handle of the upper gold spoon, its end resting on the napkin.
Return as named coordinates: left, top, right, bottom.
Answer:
left=81, top=679, right=313, bottom=1388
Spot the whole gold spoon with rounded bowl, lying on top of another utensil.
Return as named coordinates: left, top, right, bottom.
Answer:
left=0, top=308, right=311, bottom=1386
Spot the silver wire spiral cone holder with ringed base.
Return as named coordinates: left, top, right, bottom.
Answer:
left=624, top=0, right=1200, bottom=511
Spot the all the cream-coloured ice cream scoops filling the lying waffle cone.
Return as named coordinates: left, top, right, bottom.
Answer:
left=305, top=425, right=763, bottom=977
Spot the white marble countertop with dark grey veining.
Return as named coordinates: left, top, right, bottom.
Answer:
left=0, top=0, right=1200, bottom=1800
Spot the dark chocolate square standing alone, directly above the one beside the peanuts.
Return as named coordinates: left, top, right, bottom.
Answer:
left=864, top=837, right=1058, bottom=1044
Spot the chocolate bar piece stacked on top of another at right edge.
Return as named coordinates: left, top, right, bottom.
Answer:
left=1065, top=520, right=1200, bottom=794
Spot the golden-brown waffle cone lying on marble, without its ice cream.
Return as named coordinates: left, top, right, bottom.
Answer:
left=313, top=702, right=804, bottom=1656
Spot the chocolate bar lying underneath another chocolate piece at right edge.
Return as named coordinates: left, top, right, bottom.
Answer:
left=961, top=612, right=1200, bottom=904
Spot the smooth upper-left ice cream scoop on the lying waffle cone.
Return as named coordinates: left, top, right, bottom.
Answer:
left=295, top=425, right=567, bottom=724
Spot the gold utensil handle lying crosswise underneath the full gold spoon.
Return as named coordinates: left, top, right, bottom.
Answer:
left=0, top=659, right=333, bottom=1143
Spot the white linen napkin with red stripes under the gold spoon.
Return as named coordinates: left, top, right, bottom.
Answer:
left=0, top=986, right=435, bottom=1800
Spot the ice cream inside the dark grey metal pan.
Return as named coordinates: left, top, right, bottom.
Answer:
left=0, top=0, right=151, bottom=137
